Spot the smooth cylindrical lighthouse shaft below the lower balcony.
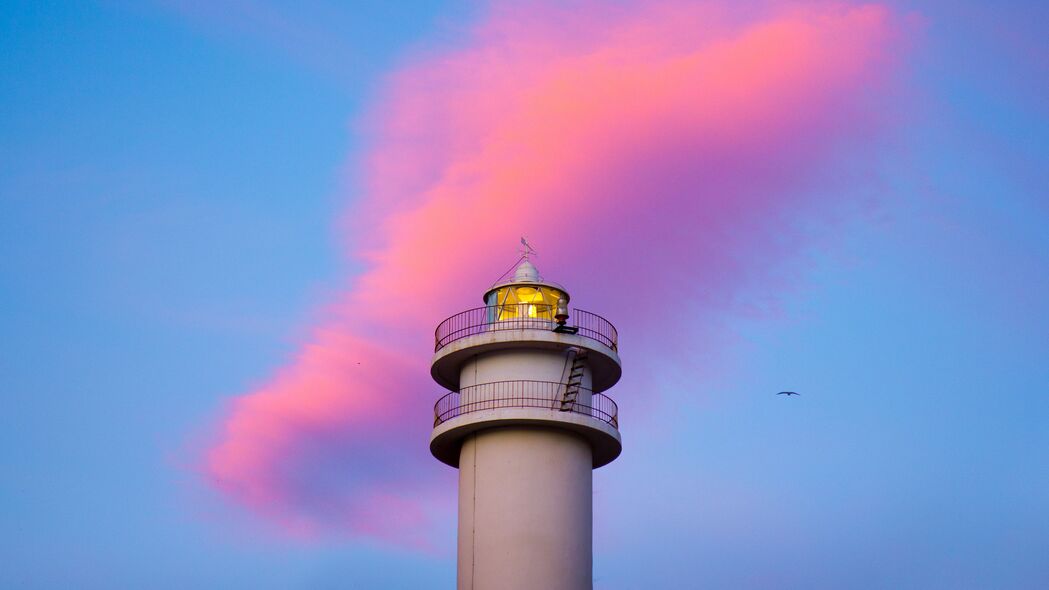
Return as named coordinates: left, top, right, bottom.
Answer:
left=458, top=425, right=593, bottom=590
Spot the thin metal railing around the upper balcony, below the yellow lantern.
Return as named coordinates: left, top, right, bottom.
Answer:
left=433, top=303, right=619, bottom=352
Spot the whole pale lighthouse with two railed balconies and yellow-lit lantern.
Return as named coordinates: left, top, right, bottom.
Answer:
left=430, top=256, right=622, bottom=590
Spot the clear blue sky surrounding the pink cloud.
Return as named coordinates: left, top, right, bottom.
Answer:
left=0, top=2, right=1049, bottom=589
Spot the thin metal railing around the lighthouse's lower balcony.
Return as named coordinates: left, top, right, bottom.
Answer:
left=433, top=381, right=619, bottom=428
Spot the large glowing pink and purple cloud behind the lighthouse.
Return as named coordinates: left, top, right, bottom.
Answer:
left=197, top=2, right=900, bottom=546
